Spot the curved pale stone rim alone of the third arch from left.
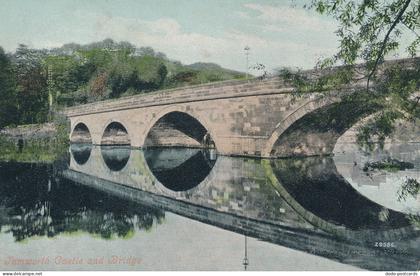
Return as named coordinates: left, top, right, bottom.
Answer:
left=140, top=105, right=219, bottom=149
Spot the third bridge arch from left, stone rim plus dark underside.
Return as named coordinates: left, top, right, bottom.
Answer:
left=141, top=105, right=219, bottom=149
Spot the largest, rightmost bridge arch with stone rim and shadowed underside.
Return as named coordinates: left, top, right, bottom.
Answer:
left=264, top=97, right=380, bottom=157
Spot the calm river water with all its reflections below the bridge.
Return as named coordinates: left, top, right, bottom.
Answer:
left=0, top=144, right=420, bottom=270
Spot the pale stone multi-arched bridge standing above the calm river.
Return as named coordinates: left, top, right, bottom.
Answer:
left=65, top=58, right=416, bottom=157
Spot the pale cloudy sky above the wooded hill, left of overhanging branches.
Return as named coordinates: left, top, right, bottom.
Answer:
left=0, top=0, right=338, bottom=71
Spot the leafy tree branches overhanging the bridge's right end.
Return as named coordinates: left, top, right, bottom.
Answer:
left=282, top=0, right=420, bottom=149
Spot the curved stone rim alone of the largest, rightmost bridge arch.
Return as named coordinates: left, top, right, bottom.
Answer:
left=262, top=96, right=340, bottom=157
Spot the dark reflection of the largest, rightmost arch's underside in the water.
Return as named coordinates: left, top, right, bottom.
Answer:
left=271, top=157, right=409, bottom=230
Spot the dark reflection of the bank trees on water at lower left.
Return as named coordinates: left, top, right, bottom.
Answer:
left=0, top=163, right=164, bottom=241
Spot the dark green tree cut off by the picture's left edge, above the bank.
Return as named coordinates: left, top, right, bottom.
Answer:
left=0, top=47, right=17, bottom=129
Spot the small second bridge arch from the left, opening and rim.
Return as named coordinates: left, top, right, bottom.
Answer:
left=101, top=120, right=131, bottom=145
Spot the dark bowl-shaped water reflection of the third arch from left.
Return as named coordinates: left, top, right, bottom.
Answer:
left=144, top=148, right=217, bottom=192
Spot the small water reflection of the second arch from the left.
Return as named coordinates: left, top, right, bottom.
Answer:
left=101, top=146, right=131, bottom=172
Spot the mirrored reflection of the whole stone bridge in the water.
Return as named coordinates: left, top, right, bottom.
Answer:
left=62, top=147, right=420, bottom=268
